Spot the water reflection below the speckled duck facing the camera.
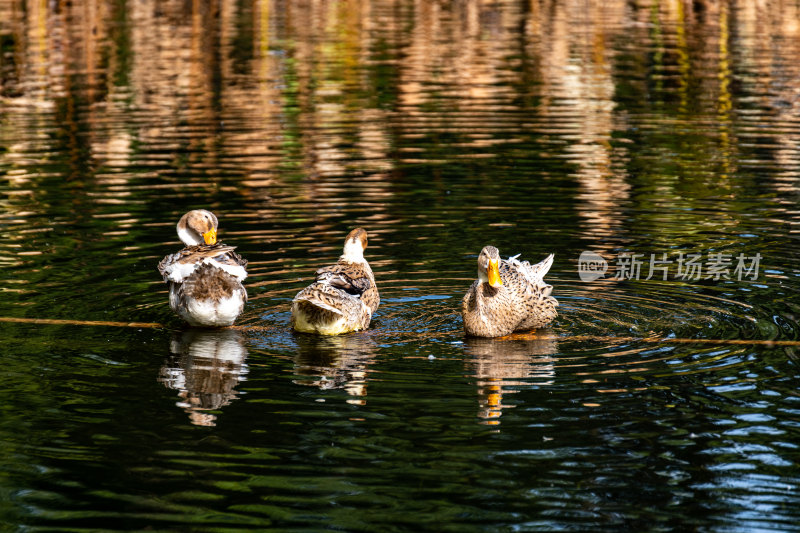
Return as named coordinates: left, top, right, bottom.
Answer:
left=464, top=334, right=558, bottom=425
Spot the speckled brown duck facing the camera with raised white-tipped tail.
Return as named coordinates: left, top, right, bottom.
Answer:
left=461, top=246, right=558, bottom=337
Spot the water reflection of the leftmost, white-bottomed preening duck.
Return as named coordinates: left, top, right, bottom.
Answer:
left=158, top=329, right=247, bottom=426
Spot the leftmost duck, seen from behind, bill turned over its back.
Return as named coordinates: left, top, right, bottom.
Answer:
left=158, top=209, right=247, bottom=327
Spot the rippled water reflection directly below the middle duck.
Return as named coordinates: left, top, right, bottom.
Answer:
left=295, top=333, right=376, bottom=405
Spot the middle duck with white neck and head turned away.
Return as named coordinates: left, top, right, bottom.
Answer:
left=291, top=228, right=381, bottom=335
